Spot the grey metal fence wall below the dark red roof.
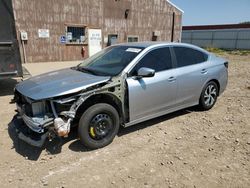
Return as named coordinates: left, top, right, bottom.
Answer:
left=182, top=29, right=250, bottom=49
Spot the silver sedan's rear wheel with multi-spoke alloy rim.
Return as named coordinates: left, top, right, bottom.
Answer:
left=199, top=81, right=219, bottom=110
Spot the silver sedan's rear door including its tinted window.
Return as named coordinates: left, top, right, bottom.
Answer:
left=173, top=47, right=209, bottom=106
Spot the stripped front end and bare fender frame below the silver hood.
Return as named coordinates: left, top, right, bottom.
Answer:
left=14, top=75, right=123, bottom=147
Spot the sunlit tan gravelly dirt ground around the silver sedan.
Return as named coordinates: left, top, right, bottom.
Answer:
left=0, top=53, right=250, bottom=188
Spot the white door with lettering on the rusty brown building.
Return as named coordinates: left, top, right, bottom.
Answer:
left=88, top=29, right=102, bottom=57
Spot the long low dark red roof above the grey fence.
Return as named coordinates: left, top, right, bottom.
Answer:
left=182, top=24, right=250, bottom=31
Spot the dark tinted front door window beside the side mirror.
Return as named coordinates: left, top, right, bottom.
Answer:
left=132, top=48, right=172, bottom=75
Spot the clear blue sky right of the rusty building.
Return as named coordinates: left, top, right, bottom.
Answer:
left=170, top=0, right=250, bottom=26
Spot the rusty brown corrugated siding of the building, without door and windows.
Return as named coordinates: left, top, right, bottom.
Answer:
left=13, top=0, right=182, bottom=62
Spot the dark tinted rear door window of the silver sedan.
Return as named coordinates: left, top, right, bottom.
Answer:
left=174, top=47, right=208, bottom=67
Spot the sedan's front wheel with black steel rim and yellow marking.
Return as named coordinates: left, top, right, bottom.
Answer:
left=78, top=103, right=120, bottom=149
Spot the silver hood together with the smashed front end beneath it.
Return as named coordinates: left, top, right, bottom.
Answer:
left=11, top=68, right=111, bottom=147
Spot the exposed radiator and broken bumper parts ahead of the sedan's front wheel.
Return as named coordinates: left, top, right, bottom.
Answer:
left=14, top=91, right=89, bottom=147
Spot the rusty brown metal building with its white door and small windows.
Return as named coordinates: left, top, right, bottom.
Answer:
left=1, top=0, right=183, bottom=63
